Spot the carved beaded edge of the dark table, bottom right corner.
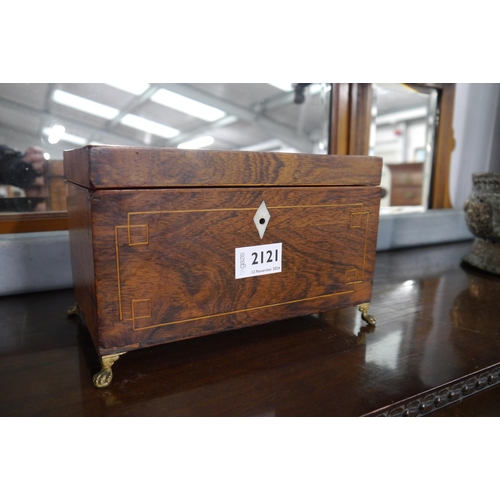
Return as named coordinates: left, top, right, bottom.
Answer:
left=362, top=363, right=500, bottom=417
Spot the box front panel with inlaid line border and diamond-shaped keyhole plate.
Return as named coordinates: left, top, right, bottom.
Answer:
left=92, top=187, right=380, bottom=350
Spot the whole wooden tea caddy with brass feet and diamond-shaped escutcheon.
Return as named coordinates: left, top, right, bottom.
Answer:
left=64, top=146, right=382, bottom=387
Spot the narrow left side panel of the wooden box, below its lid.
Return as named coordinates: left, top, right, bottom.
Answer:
left=66, top=182, right=98, bottom=346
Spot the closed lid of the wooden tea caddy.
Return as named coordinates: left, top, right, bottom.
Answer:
left=64, top=146, right=382, bottom=189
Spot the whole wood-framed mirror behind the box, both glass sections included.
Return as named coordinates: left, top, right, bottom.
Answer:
left=0, top=83, right=454, bottom=233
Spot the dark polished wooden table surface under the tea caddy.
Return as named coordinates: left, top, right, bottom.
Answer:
left=0, top=242, right=500, bottom=416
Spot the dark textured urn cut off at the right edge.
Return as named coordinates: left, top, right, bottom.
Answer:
left=464, top=172, right=500, bottom=274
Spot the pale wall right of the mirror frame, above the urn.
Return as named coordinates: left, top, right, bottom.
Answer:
left=450, top=83, right=500, bottom=208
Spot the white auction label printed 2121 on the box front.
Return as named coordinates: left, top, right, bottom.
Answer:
left=234, top=243, right=282, bottom=279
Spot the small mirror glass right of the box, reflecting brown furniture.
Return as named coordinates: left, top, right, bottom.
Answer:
left=369, top=83, right=437, bottom=213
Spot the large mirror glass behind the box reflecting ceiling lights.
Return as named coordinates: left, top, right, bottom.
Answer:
left=0, top=83, right=331, bottom=212
